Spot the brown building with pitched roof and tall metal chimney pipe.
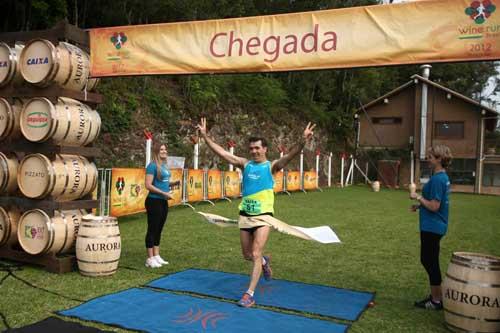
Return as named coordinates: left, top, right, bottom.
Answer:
left=356, top=65, right=500, bottom=194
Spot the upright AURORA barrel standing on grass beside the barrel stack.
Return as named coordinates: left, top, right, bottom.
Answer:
left=76, top=215, right=121, bottom=276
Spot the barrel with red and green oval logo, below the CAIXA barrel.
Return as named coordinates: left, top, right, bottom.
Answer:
left=20, top=97, right=101, bottom=146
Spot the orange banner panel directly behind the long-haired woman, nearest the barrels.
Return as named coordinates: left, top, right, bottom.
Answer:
left=110, top=168, right=148, bottom=217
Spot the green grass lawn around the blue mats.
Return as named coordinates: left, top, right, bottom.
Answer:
left=0, top=186, right=500, bottom=333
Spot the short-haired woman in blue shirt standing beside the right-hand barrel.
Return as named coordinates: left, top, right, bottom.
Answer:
left=410, top=145, right=452, bottom=310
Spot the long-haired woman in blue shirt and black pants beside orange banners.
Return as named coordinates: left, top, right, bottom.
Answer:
left=145, top=144, right=172, bottom=268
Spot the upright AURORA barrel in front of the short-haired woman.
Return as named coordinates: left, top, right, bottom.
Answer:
left=443, top=252, right=500, bottom=333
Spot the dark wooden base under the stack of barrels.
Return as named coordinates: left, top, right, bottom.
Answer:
left=0, top=245, right=77, bottom=274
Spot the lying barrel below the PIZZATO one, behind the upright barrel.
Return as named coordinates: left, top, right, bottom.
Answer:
left=17, top=209, right=82, bottom=255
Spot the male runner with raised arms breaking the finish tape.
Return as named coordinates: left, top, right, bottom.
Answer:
left=196, top=118, right=316, bottom=307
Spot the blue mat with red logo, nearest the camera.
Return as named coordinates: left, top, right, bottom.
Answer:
left=59, top=288, right=348, bottom=333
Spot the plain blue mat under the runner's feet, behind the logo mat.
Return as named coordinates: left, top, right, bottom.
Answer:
left=147, top=269, right=374, bottom=320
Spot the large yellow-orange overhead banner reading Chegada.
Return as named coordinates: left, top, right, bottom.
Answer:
left=90, top=0, right=500, bottom=77
